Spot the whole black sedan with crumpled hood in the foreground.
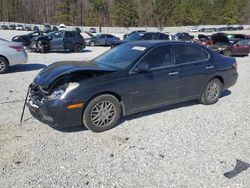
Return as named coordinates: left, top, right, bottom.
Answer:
left=27, top=41, right=238, bottom=132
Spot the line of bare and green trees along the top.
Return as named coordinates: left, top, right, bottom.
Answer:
left=0, top=0, right=250, bottom=27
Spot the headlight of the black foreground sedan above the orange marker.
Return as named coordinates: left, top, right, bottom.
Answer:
left=49, top=83, right=80, bottom=99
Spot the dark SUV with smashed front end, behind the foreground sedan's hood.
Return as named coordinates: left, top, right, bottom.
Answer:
left=31, top=31, right=86, bottom=53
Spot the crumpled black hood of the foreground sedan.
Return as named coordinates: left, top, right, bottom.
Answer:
left=34, top=61, right=116, bottom=88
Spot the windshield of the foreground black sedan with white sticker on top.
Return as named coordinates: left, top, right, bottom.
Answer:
left=93, top=43, right=147, bottom=69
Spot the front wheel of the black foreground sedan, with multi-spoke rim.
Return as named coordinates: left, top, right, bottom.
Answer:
left=83, top=94, right=121, bottom=132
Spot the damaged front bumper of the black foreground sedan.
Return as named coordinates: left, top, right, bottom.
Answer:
left=26, top=84, right=83, bottom=127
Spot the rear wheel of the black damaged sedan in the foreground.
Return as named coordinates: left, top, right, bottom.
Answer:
left=200, top=78, right=222, bottom=105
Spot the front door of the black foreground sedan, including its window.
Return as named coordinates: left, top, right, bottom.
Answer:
left=128, top=45, right=179, bottom=112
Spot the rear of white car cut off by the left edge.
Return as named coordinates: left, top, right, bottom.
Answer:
left=0, top=38, right=28, bottom=74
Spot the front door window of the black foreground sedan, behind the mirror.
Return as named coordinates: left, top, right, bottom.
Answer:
left=141, top=45, right=174, bottom=69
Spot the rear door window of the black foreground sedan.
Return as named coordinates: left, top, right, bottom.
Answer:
left=176, top=45, right=209, bottom=64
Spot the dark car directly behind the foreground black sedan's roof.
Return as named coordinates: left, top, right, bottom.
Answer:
left=111, top=32, right=170, bottom=48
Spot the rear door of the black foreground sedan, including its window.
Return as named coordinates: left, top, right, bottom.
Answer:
left=175, top=43, right=215, bottom=99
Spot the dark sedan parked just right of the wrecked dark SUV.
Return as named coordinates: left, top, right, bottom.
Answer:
left=85, top=34, right=120, bottom=46
